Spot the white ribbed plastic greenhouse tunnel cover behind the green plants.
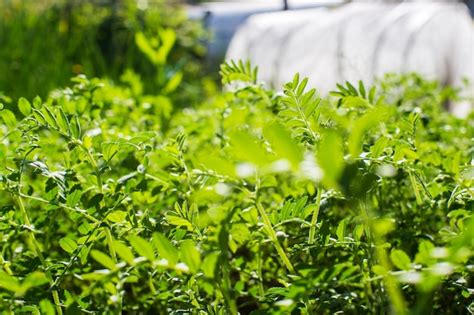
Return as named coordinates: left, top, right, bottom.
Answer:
left=226, top=1, right=474, bottom=116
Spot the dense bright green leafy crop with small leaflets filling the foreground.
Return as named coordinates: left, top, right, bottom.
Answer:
left=0, top=60, right=474, bottom=314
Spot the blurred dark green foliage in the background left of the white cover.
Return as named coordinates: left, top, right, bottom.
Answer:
left=0, top=0, right=205, bottom=99
